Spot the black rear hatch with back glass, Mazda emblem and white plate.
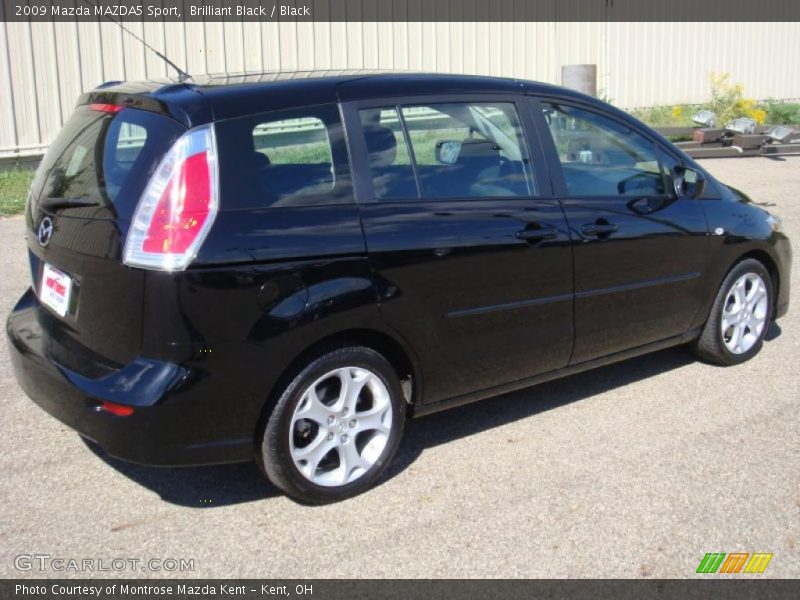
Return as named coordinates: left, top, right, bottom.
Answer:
left=26, top=104, right=186, bottom=376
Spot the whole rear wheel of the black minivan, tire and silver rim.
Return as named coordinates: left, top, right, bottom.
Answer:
left=256, top=346, right=406, bottom=504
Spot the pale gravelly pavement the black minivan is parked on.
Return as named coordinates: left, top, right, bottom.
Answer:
left=0, top=157, right=800, bottom=578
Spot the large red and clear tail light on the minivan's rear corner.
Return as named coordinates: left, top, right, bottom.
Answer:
left=123, top=125, right=219, bottom=271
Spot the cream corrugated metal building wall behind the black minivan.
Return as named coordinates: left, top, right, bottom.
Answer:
left=0, top=20, right=800, bottom=157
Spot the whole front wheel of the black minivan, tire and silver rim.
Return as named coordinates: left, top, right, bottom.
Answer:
left=693, top=258, right=774, bottom=366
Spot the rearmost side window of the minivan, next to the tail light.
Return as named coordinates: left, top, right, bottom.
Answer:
left=216, top=105, right=353, bottom=210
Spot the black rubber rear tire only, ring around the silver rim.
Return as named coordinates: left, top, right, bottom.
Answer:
left=260, top=347, right=406, bottom=504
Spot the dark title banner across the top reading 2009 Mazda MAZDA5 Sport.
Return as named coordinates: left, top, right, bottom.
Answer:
left=0, top=0, right=800, bottom=22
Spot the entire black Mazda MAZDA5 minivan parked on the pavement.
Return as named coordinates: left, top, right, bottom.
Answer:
left=7, top=73, right=791, bottom=503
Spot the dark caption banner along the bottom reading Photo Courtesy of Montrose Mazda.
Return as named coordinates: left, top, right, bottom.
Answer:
left=0, top=576, right=800, bottom=600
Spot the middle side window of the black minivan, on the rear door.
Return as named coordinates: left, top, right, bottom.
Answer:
left=360, top=102, right=534, bottom=198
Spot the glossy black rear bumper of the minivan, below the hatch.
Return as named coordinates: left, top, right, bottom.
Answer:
left=6, top=289, right=253, bottom=466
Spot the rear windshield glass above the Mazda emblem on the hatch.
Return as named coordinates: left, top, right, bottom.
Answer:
left=33, top=106, right=185, bottom=219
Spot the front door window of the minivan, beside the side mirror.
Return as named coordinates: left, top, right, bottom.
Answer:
left=544, top=104, right=665, bottom=197
